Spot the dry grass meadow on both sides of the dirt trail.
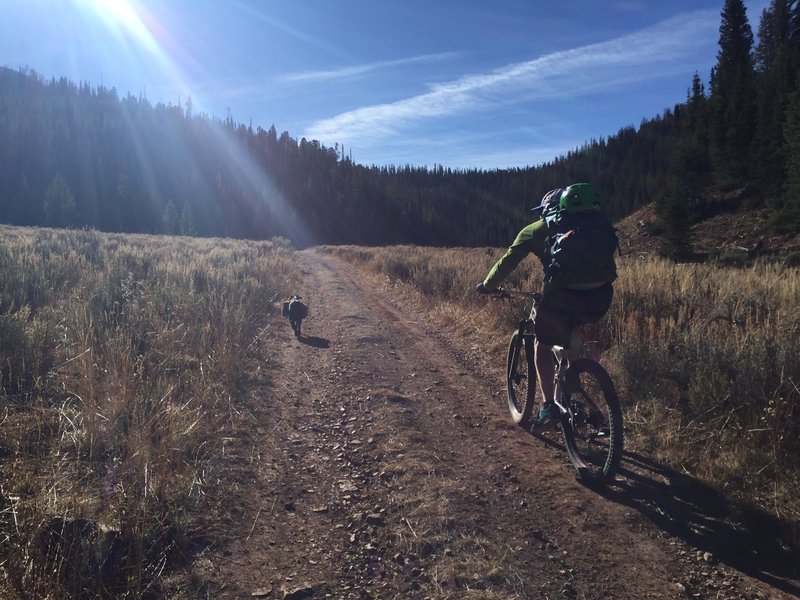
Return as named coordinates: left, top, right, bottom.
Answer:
left=0, top=226, right=800, bottom=598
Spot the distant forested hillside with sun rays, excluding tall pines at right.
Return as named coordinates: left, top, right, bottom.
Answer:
left=0, top=70, right=674, bottom=245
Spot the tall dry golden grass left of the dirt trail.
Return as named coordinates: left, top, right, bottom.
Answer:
left=0, top=227, right=297, bottom=598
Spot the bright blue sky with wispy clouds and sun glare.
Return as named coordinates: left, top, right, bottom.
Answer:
left=0, top=0, right=768, bottom=169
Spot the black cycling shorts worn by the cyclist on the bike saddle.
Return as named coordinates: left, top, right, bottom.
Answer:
left=533, top=283, right=614, bottom=348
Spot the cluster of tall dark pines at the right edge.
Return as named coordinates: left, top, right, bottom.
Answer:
left=655, top=0, right=800, bottom=255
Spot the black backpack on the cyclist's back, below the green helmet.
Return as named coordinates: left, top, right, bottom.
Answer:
left=544, top=209, right=619, bottom=284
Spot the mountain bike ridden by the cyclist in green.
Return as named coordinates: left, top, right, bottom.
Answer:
left=491, top=288, right=624, bottom=482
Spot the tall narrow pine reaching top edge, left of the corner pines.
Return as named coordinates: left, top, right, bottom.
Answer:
left=710, top=0, right=754, bottom=185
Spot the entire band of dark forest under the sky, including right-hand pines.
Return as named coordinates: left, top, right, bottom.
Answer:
left=0, top=0, right=800, bottom=250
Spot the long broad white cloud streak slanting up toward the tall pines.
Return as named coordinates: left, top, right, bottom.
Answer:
left=305, top=10, right=719, bottom=144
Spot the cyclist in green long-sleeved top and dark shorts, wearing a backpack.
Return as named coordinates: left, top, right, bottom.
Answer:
left=477, top=183, right=617, bottom=427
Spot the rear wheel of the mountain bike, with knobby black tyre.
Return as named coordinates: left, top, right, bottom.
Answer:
left=562, top=358, right=624, bottom=482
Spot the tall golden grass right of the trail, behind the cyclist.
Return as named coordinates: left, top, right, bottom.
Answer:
left=327, top=246, right=800, bottom=543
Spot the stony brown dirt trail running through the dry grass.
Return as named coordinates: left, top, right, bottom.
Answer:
left=209, top=251, right=800, bottom=599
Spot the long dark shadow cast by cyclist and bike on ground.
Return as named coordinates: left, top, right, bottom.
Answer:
left=531, top=432, right=800, bottom=596
